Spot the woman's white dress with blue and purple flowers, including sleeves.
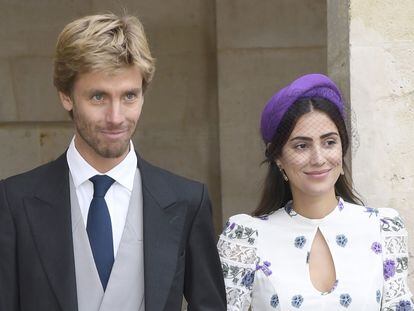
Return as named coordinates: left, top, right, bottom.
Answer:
left=218, top=199, right=413, bottom=311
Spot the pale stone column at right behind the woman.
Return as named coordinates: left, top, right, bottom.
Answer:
left=327, top=0, right=414, bottom=289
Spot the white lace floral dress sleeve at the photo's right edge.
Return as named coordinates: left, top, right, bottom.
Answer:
left=380, top=208, right=414, bottom=311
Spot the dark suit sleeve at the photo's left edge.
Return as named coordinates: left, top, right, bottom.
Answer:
left=0, top=181, right=19, bottom=311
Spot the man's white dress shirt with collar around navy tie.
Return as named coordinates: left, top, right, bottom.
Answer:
left=66, top=138, right=141, bottom=258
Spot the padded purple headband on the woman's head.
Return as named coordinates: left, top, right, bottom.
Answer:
left=260, top=73, right=344, bottom=144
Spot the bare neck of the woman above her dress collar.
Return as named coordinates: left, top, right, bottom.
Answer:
left=292, top=191, right=338, bottom=219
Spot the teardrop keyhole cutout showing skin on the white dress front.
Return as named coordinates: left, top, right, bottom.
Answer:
left=307, top=227, right=338, bottom=295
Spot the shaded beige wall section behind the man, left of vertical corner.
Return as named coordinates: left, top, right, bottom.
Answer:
left=0, top=0, right=221, bottom=228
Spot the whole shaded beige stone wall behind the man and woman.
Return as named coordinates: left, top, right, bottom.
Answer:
left=0, top=0, right=326, bottom=231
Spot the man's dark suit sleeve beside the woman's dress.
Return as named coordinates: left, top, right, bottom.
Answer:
left=184, top=185, right=226, bottom=311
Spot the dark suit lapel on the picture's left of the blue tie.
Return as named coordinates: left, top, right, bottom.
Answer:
left=24, top=154, right=77, bottom=311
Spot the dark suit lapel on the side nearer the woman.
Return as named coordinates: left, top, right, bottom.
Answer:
left=138, top=156, right=186, bottom=310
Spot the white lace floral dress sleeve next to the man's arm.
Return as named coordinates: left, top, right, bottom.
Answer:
left=217, top=215, right=258, bottom=311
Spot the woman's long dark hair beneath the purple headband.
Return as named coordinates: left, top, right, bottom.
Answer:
left=252, top=98, right=363, bottom=216
